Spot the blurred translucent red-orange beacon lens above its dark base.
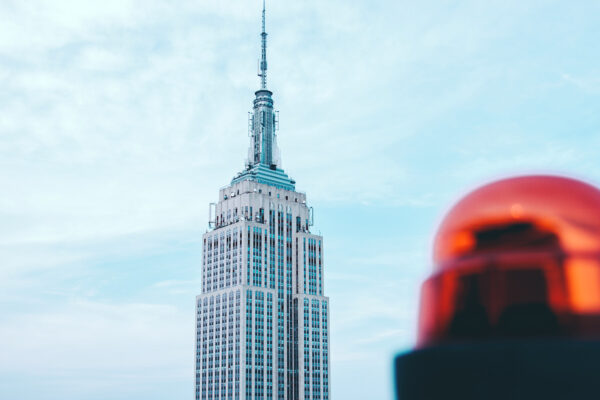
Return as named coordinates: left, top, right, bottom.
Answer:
left=418, top=176, right=600, bottom=348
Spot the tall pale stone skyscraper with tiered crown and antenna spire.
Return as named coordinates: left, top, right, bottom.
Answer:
left=195, top=0, right=330, bottom=400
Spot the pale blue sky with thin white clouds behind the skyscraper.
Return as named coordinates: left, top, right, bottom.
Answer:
left=0, top=0, right=600, bottom=400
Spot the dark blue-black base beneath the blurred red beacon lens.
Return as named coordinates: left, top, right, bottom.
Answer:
left=395, top=340, right=600, bottom=400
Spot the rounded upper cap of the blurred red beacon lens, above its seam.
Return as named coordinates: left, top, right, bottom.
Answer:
left=434, top=176, right=600, bottom=268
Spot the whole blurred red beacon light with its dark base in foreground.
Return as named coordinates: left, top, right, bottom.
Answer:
left=396, top=176, right=600, bottom=400
